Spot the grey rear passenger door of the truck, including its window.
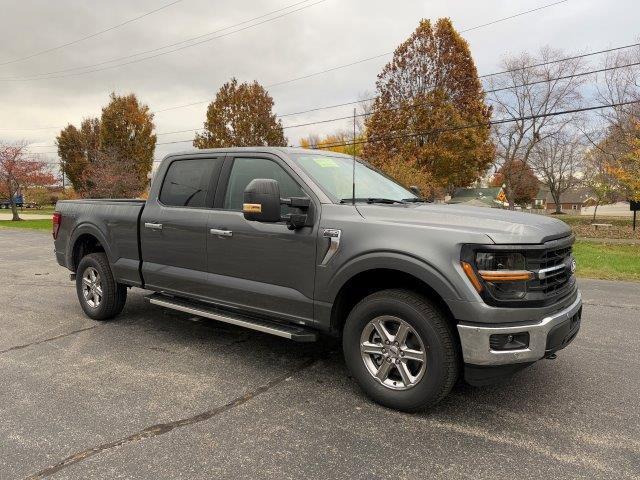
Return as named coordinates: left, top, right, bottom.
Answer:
left=140, top=155, right=224, bottom=297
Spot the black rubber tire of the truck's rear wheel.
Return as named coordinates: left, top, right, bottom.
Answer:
left=76, top=253, right=127, bottom=320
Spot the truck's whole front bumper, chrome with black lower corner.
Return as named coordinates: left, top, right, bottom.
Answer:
left=458, top=292, right=582, bottom=365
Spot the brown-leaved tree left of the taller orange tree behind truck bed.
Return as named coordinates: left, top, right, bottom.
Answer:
left=56, top=118, right=100, bottom=193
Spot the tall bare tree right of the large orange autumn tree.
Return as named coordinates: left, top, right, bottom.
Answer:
left=487, top=47, right=585, bottom=208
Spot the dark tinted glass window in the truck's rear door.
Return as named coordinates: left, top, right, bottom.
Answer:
left=160, top=158, right=222, bottom=207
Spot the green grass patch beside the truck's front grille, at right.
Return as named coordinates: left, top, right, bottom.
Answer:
left=573, top=242, right=640, bottom=282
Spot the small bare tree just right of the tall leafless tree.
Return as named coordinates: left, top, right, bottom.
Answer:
left=530, top=131, right=585, bottom=213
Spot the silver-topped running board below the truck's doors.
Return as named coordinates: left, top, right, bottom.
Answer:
left=145, top=293, right=318, bottom=342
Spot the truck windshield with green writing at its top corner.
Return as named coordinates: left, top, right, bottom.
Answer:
left=291, top=153, right=417, bottom=202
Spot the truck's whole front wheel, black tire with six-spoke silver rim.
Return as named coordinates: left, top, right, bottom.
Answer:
left=342, top=290, right=459, bottom=412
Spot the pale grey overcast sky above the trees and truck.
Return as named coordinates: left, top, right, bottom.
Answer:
left=0, top=0, right=640, bottom=171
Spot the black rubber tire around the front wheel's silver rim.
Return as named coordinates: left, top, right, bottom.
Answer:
left=342, top=289, right=460, bottom=412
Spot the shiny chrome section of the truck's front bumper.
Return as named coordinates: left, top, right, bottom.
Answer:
left=458, top=292, right=582, bottom=365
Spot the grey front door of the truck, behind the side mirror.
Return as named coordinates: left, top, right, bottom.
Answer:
left=207, top=154, right=319, bottom=323
